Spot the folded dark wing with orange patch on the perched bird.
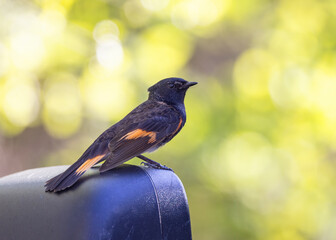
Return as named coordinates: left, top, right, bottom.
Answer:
left=100, top=111, right=182, bottom=172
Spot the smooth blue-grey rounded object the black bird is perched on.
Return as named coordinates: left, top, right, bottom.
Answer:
left=0, top=165, right=191, bottom=240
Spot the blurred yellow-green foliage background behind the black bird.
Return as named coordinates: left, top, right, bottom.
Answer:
left=0, top=0, right=336, bottom=240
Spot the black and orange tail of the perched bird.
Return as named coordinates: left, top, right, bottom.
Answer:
left=44, top=154, right=106, bottom=192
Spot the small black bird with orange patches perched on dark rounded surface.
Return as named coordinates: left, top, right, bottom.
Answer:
left=45, top=77, right=197, bottom=192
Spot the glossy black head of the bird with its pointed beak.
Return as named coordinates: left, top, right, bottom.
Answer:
left=148, top=78, right=197, bottom=104
